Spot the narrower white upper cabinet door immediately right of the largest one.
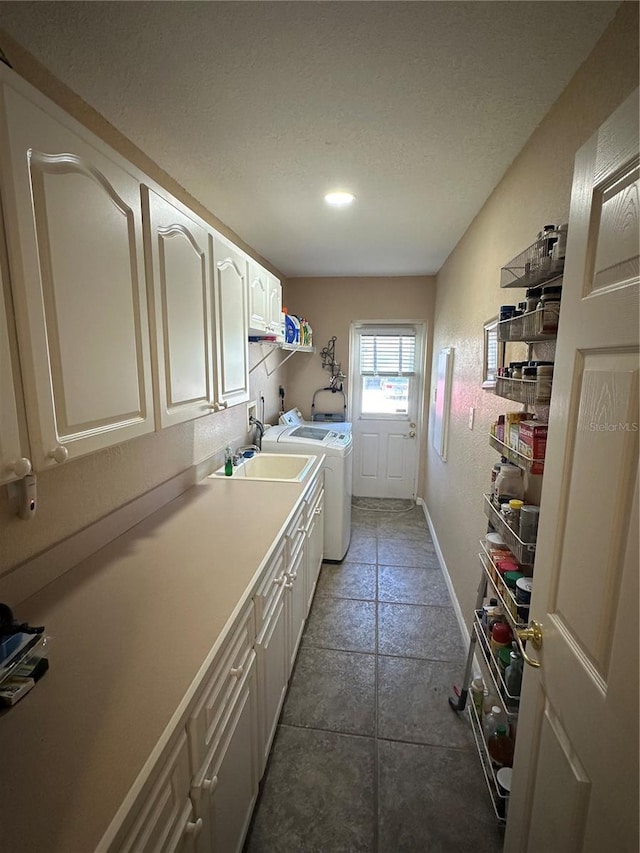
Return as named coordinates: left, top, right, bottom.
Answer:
left=142, top=186, right=214, bottom=427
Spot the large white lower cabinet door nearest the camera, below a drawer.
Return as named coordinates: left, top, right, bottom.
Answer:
left=191, top=657, right=259, bottom=853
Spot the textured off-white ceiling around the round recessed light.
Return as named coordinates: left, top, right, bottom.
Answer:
left=0, top=0, right=618, bottom=276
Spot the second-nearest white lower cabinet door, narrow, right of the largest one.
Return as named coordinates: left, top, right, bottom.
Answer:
left=256, top=590, right=289, bottom=778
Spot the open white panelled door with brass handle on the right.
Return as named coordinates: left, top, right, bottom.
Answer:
left=505, top=91, right=640, bottom=853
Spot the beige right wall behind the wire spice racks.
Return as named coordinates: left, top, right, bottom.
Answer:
left=425, top=3, right=638, bottom=617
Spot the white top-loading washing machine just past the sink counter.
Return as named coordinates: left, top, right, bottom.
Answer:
left=262, top=422, right=353, bottom=563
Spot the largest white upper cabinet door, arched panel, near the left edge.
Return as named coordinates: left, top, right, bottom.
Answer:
left=0, top=68, right=154, bottom=470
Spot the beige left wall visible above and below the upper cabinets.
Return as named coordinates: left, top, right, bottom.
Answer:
left=0, top=33, right=288, bottom=580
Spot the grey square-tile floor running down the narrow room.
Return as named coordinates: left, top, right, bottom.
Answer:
left=245, top=498, right=502, bottom=853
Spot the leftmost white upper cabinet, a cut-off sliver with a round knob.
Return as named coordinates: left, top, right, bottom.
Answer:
left=0, top=236, right=31, bottom=483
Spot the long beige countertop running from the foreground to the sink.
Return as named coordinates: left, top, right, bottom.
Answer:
left=0, top=466, right=318, bottom=853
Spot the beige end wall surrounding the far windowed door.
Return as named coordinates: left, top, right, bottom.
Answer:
left=284, top=276, right=435, bottom=450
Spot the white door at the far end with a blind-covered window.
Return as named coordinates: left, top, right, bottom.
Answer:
left=350, top=321, right=424, bottom=498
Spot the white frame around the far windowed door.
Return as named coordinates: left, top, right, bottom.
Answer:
left=348, top=319, right=427, bottom=500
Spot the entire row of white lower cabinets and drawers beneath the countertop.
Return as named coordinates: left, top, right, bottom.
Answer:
left=107, top=472, right=324, bottom=853
